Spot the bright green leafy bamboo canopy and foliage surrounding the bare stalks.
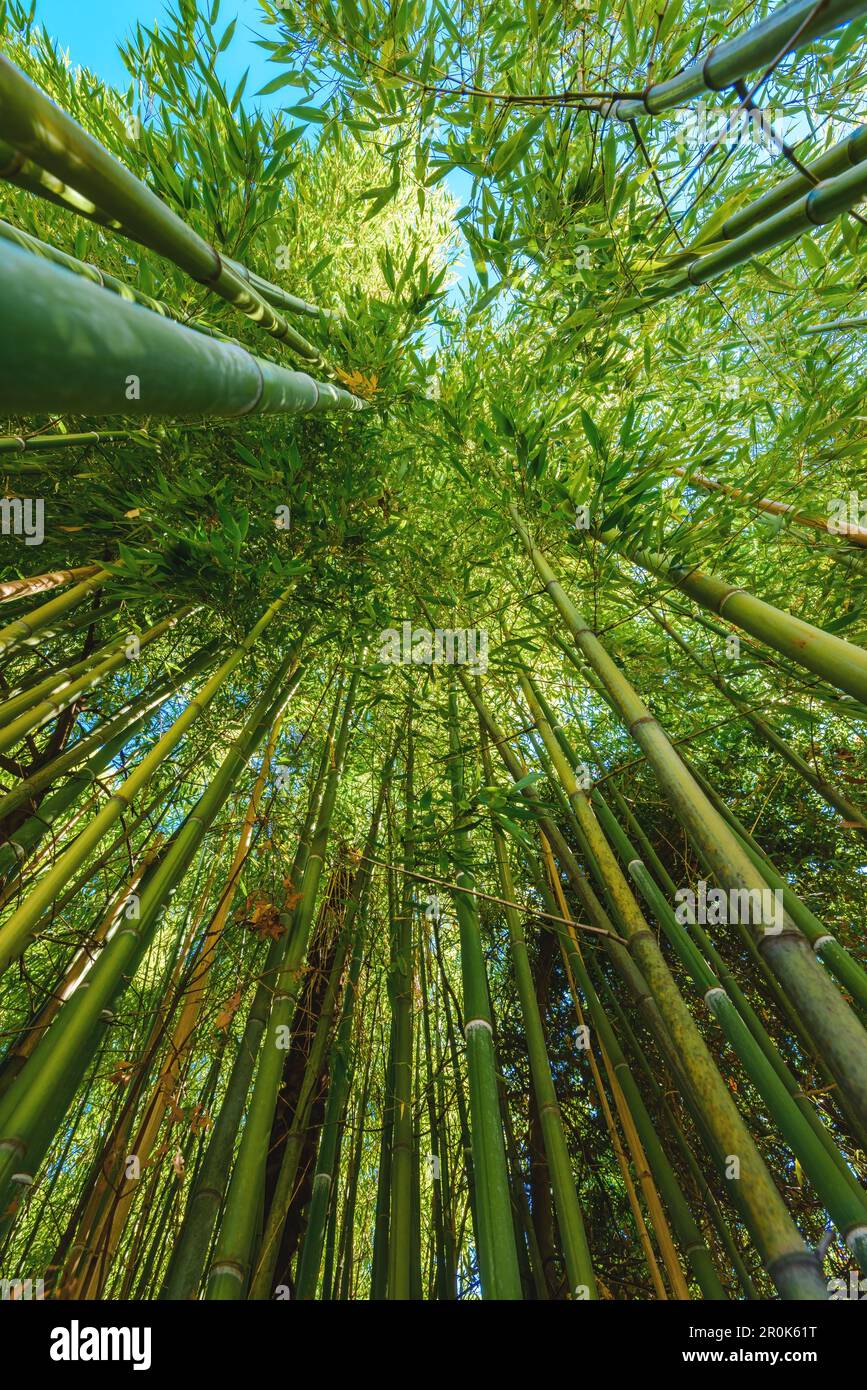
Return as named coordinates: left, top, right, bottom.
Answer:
left=0, top=0, right=867, bottom=1300
